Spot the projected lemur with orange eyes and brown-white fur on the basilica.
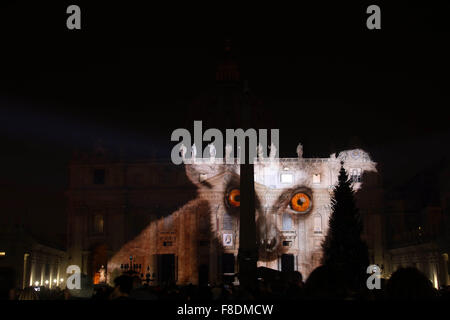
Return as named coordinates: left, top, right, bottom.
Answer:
left=102, top=149, right=381, bottom=284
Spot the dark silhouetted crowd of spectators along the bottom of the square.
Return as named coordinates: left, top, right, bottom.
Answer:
left=3, top=266, right=450, bottom=301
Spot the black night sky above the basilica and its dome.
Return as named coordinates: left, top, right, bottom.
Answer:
left=0, top=1, right=450, bottom=244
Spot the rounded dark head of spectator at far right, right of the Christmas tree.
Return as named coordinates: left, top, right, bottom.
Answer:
left=386, top=267, right=436, bottom=300
